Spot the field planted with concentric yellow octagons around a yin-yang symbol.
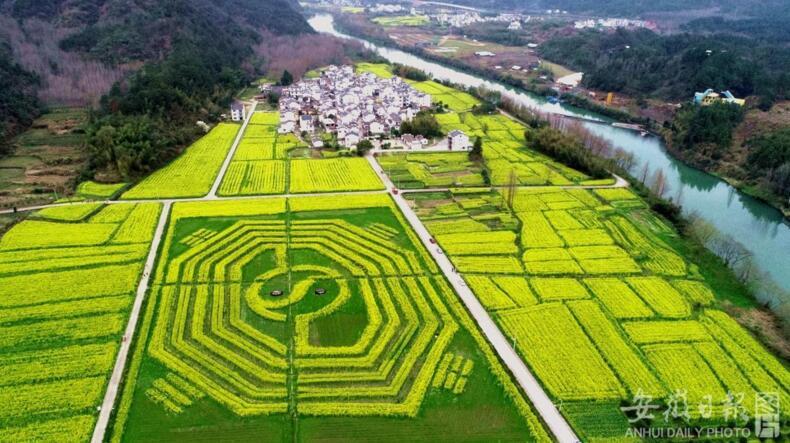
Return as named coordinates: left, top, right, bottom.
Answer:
left=112, top=198, right=547, bottom=441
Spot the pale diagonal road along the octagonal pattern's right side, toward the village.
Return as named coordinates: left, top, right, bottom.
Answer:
left=367, top=155, right=580, bottom=443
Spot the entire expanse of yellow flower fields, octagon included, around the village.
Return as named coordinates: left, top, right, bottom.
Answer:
left=0, top=60, right=790, bottom=442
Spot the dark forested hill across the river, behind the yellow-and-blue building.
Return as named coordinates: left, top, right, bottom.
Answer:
left=540, top=29, right=790, bottom=107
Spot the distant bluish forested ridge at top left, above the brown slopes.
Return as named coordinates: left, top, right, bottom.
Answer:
left=8, top=0, right=310, bottom=64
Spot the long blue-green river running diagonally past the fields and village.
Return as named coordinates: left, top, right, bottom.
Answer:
left=309, top=14, right=790, bottom=302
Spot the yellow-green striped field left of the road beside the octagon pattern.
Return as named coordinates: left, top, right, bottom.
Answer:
left=0, top=203, right=161, bottom=441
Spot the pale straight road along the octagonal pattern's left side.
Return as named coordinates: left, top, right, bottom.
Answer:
left=91, top=202, right=171, bottom=443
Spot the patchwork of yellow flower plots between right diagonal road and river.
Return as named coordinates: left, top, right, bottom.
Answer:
left=413, top=188, right=790, bottom=439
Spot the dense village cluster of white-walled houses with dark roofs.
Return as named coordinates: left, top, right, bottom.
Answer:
left=279, top=66, right=440, bottom=148
